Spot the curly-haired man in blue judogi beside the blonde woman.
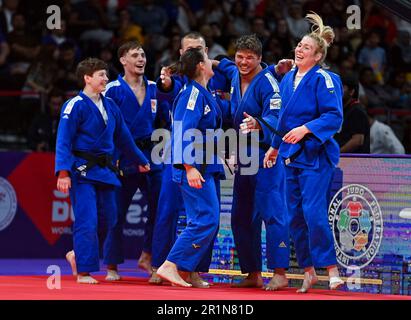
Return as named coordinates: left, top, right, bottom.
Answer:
left=218, top=36, right=290, bottom=290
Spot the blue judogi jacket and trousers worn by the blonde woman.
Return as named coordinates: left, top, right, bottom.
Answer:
left=272, top=66, right=343, bottom=268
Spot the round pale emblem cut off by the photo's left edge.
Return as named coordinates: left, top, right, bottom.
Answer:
left=0, top=177, right=17, bottom=231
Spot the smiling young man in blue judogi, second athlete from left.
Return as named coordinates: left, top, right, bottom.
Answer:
left=104, top=41, right=163, bottom=280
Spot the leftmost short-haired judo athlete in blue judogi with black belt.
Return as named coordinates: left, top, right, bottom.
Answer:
left=55, top=58, right=150, bottom=283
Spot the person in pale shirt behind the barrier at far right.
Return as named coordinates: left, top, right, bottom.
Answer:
left=369, top=114, right=405, bottom=154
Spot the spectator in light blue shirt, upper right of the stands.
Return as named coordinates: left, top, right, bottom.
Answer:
left=358, top=31, right=387, bottom=84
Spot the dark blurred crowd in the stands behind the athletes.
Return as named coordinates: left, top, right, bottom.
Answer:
left=0, top=0, right=411, bottom=153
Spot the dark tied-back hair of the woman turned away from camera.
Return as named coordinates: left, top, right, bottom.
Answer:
left=168, top=48, right=204, bottom=80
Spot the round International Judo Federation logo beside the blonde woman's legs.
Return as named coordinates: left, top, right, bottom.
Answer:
left=328, top=184, right=383, bottom=270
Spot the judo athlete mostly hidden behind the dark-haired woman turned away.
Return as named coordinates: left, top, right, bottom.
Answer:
left=149, top=32, right=233, bottom=287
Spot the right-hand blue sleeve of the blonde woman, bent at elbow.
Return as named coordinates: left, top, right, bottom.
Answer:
left=305, top=70, right=343, bottom=143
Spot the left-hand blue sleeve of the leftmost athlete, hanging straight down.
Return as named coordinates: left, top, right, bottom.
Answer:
left=55, top=97, right=81, bottom=175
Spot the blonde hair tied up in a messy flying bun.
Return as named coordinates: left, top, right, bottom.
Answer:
left=305, top=11, right=335, bottom=65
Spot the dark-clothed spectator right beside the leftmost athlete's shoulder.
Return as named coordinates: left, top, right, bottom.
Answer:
left=27, top=89, right=65, bottom=152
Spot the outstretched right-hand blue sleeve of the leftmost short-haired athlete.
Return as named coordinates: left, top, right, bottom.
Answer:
left=113, top=102, right=149, bottom=165
